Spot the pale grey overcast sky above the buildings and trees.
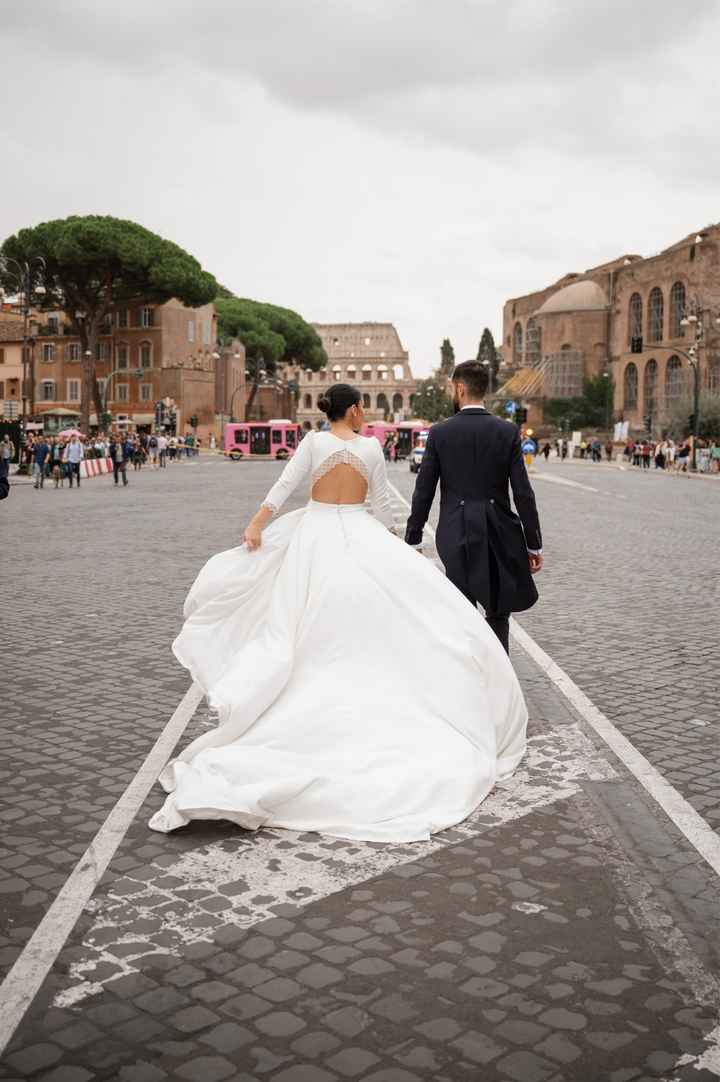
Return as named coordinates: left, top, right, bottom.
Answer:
left=0, top=0, right=720, bottom=374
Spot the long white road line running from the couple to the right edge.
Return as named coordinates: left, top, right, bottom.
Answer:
left=389, top=483, right=720, bottom=876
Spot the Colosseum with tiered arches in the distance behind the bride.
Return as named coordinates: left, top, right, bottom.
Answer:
left=297, top=324, right=416, bottom=427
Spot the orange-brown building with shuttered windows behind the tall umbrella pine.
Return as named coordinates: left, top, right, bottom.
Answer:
left=0, top=300, right=245, bottom=443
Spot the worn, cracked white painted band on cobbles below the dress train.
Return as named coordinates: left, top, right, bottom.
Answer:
left=54, top=724, right=617, bottom=1007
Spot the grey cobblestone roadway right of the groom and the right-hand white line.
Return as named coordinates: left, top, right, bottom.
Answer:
left=395, top=460, right=720, bottom=829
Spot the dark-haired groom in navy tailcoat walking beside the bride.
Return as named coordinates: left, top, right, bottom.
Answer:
left=405, top=360, right=542, bottom=652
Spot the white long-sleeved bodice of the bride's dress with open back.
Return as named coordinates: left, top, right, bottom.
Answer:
left=263, top=432, right=392, bottom=527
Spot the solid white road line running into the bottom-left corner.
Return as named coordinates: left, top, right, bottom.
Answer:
left=0, top=685, right=202, bottom=1054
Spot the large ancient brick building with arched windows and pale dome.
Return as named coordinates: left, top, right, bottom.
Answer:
left=501, top=225, right=720, bottom=431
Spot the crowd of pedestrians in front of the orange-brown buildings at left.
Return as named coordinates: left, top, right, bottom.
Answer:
left=6, top=431, right=201, bottom=489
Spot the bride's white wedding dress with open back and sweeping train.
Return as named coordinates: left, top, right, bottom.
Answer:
left=149, top=432, right=527, bottom=842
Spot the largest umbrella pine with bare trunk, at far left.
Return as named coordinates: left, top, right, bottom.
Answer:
left=0, top=214, right=218, bottom=428
